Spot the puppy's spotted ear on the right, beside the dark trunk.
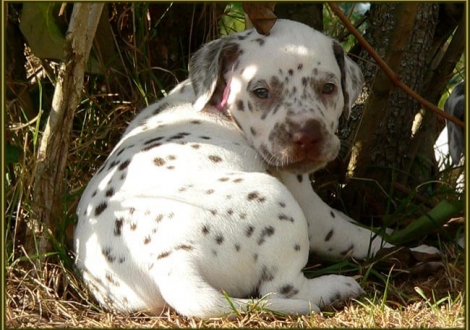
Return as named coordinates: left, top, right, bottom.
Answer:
left=333, top=40, right=364, bottom=118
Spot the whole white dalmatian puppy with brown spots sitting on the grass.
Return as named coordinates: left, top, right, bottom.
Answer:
left=74, top=20, right=435, bottom=318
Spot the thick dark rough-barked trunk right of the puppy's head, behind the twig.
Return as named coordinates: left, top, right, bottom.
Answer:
left=343, top=3, right=439, bottom=220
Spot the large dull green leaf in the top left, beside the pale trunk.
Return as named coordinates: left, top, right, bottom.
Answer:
left=20, top=1, right=65, bottom=59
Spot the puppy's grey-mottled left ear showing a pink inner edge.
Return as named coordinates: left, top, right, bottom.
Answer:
left=189, top=36, right=241, bottom=111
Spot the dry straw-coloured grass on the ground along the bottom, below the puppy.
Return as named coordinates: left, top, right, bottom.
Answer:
left=6, top=244, right=465, bottom=329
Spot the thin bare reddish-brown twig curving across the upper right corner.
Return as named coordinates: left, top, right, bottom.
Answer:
left=328, top=2, right=465, bottom=128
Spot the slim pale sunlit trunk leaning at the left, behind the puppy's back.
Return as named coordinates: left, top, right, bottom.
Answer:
left=25, top=3, right=103, bottom=258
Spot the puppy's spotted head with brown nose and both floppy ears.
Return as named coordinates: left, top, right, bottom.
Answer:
left=190, top=20, right=363, bottom=173
